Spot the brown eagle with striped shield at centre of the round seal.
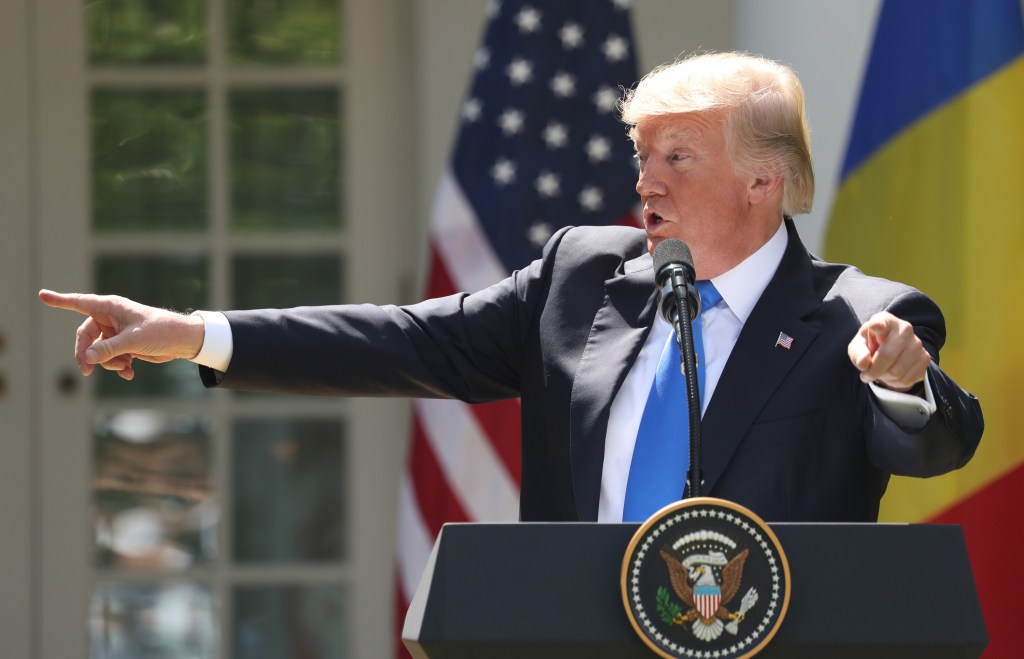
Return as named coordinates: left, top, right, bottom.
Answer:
left=660, top=548, right=750, bottom=641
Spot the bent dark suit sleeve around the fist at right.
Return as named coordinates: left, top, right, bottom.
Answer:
left=863, top=291, right=984, bottom=478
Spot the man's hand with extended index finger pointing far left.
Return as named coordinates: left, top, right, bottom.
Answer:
left=39, top=290, right=206, bottom=380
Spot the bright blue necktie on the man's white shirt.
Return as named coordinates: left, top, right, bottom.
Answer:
left=623, top=281, right=722, bottom=522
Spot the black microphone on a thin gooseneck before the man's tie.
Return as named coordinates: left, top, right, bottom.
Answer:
left=653, top=238, right=703, bottom=498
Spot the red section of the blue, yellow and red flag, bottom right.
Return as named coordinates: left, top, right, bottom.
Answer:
left=929, top=465, right=1024, bottom=659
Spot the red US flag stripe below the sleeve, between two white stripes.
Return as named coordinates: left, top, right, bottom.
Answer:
left=409, top=413, right=470, bottom=537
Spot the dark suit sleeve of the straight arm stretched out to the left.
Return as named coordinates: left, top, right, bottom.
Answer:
left=200, top=226, right=564, bottom=403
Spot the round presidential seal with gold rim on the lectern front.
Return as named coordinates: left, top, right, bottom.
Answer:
left=622, top=497, right=790, bottom=659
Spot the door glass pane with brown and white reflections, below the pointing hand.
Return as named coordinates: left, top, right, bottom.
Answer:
left=92, top=409, right=219, bottom=569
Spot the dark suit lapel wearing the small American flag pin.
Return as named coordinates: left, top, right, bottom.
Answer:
left=700, top=221, right=821, bottom=494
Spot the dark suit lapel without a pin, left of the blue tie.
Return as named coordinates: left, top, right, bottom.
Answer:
left=569, top=254, right=657, bottom=520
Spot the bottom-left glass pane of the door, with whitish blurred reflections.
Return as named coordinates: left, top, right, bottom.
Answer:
left=89, top=583, right=218, bottom=659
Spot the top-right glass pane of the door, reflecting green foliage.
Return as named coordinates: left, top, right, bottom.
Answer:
left=227, top=0, right=341, bottom=65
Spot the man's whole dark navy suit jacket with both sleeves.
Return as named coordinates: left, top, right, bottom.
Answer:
left=203, top=220, right=983, bottom=521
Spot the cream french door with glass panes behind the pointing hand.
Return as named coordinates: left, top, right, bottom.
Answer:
left=11, top=0, right=416, bottom=659
